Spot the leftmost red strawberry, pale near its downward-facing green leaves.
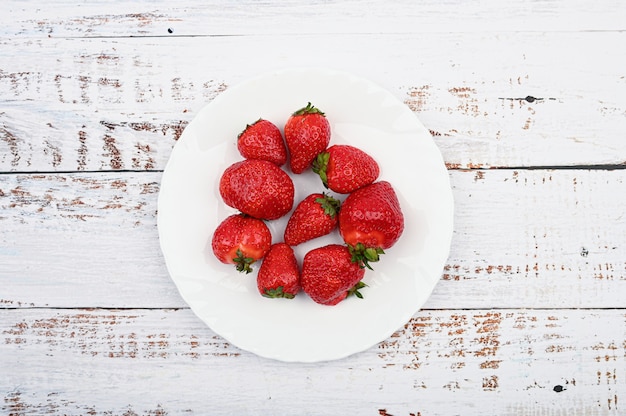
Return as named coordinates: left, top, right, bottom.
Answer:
left=211, top=214, right=272, bottom=273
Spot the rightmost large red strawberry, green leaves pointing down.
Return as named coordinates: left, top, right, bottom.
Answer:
left=339, top=181, right=404, bottom=269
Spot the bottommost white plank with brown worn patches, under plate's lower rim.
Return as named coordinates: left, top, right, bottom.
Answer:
left=0, top=309, right=626, bottom=416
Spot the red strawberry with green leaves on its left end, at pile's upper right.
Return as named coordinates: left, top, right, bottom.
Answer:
left=313, top=144, right=380, bottom=194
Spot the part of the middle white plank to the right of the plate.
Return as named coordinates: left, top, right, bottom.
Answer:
left=427, top=170, right=626, bottom=308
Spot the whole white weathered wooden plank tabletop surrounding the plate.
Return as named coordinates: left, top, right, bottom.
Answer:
left=0, top=0, right=626, bottom=416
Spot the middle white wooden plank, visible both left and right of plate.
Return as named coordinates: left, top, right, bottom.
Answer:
left=0, top=170, right=626, bottom=309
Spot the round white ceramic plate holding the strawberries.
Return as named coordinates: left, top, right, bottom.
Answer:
left=158, top=69, right=453, bottom=362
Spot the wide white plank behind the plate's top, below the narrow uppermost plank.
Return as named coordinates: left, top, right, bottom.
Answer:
left=0, top=31, right=626, bottom=172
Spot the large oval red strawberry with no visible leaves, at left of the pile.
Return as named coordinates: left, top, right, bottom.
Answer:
left=220, top=159, right=294, bottom=220
